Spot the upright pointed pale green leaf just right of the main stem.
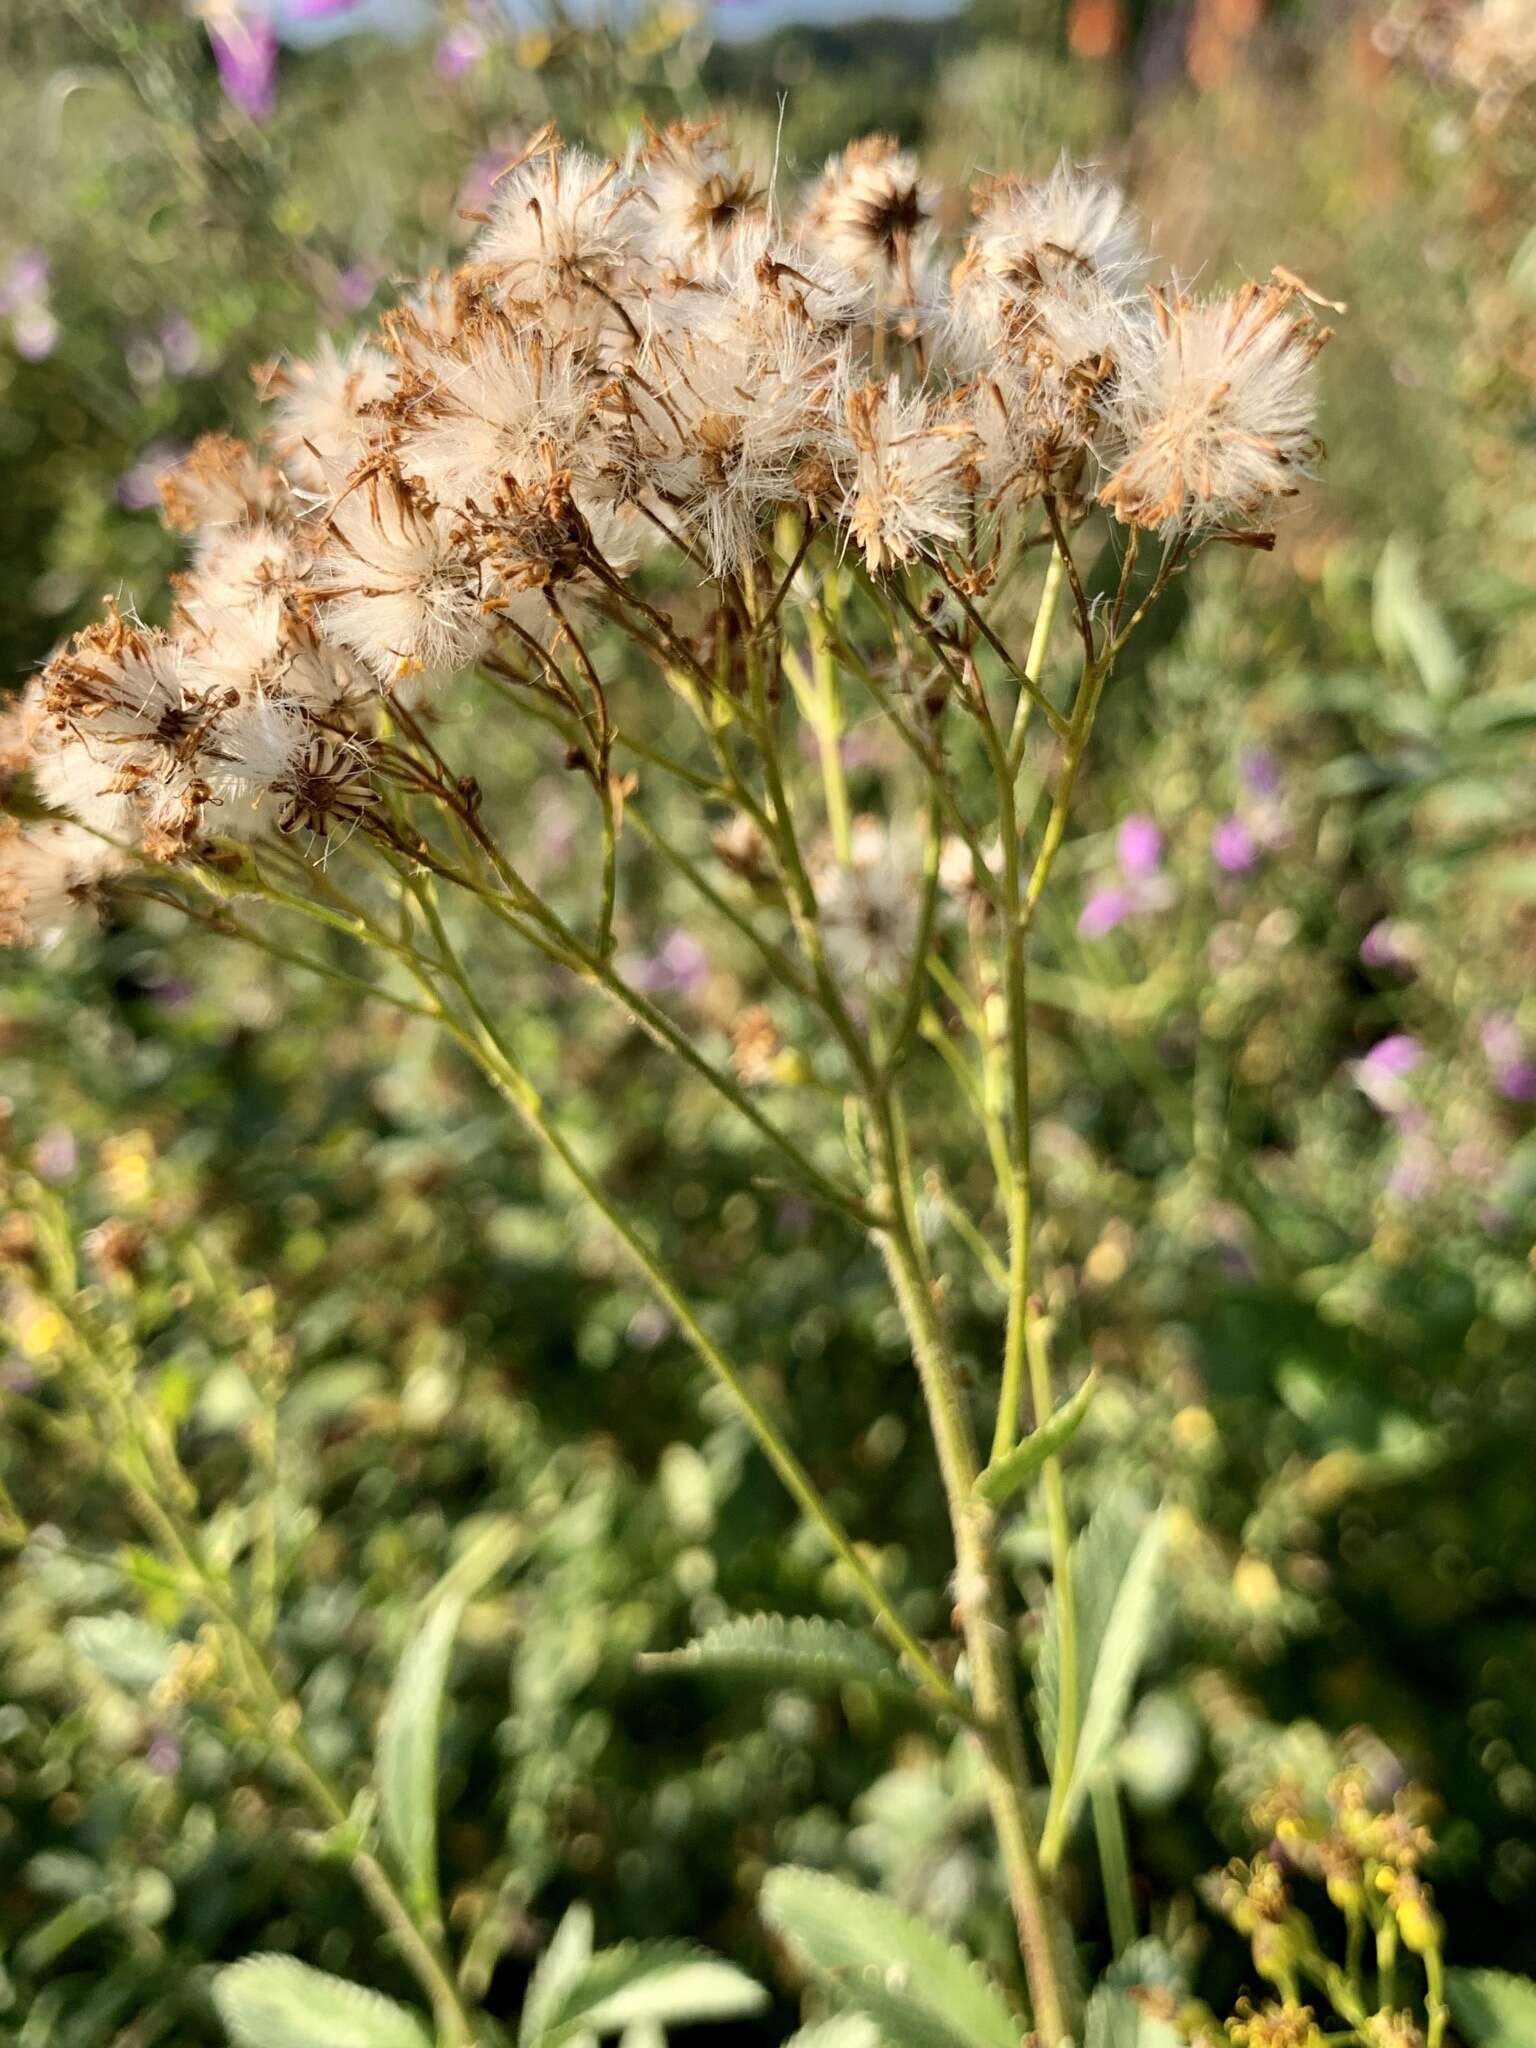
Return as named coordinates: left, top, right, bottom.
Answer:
left=1036, top=1499, right=1163, bottom=1839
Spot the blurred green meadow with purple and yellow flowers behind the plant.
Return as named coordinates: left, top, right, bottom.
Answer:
left=0, top=0, right=1536, bottom=2048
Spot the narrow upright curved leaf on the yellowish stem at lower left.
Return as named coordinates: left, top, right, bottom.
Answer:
left=373, top=1520, right=520, bottom=1913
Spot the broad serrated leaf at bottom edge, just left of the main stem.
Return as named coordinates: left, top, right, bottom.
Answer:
left=760, top=1868, right=1022, bottom=2048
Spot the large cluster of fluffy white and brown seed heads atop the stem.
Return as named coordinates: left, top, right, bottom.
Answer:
left=0, top=125, right=1327, bottom=944
